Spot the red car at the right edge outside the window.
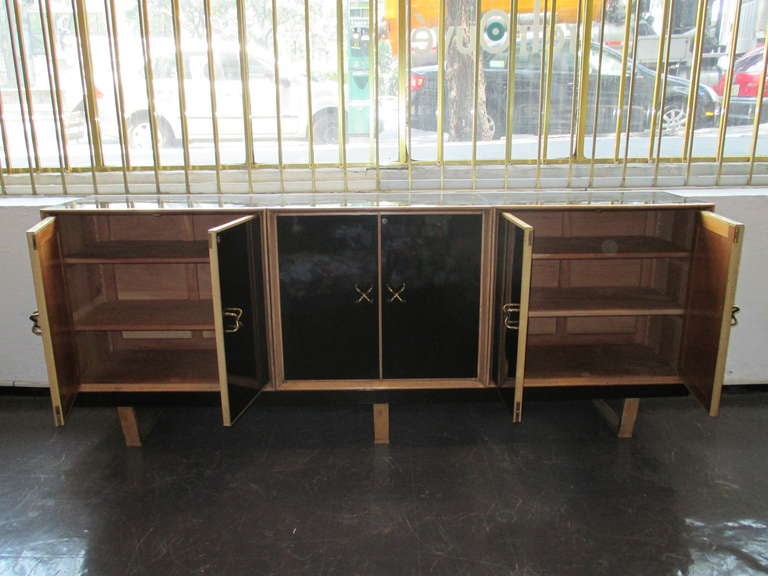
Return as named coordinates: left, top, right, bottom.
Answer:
left=712, top=46, right=768, bottom=124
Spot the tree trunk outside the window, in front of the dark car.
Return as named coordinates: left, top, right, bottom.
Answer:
left=444, top=0, right=494, bottom=141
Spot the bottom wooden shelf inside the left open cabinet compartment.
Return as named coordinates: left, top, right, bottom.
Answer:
left=80, top=350, right=219, bottom=392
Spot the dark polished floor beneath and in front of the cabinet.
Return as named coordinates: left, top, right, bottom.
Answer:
left=0, top=392, right=768, bottom=576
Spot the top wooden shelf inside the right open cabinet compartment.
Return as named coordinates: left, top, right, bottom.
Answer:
left=533, top=236, right=690, bottom=260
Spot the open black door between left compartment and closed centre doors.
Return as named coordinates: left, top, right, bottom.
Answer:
left=208, top=214, right=270, bottom=426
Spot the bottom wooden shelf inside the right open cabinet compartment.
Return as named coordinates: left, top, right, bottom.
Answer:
left=525, top=344, right=682, bottom=387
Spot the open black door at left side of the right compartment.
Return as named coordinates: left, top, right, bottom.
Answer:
left=494, top=212, right=533, bottom=422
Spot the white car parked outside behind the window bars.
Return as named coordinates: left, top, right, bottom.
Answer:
left=70, top=48, right=338, bottom=147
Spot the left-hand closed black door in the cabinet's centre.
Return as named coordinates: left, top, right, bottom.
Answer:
left=277, top=215, right=379, bottom=380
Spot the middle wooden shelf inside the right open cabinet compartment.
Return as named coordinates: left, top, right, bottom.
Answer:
left=528, top=287, right=685, bottom=318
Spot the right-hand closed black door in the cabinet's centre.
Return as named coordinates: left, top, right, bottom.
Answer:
left=381, top=214, right=483, bottom=379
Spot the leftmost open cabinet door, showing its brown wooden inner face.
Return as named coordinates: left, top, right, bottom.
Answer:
left=27, top=218, right=80, bottom=426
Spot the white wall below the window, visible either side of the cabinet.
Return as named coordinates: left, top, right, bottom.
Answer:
left=0, top=190, right=768, bottom=386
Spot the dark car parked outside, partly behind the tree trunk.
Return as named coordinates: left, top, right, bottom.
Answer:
left=410, top=44, right=719, bottom=138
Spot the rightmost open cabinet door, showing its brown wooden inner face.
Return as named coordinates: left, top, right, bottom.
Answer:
left=680, top=212, right=744, bottom=416
